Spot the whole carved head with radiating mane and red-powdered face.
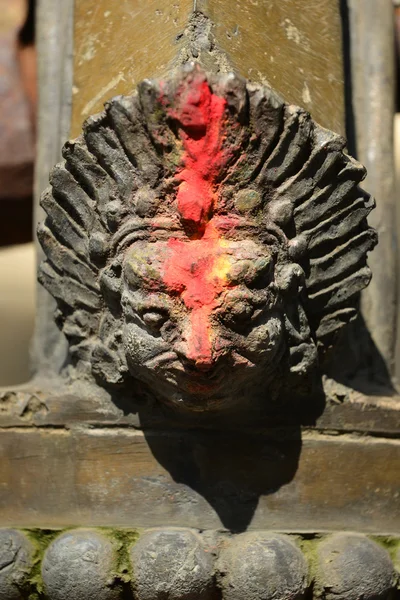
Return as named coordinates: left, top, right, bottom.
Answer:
left=38, top=64, right=376, bottom=411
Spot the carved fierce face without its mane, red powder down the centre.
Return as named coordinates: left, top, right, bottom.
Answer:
left=122, top=234, right=284, bottom=410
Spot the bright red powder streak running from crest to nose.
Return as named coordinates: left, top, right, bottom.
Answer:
left=159, top=76, right=227, bottom=369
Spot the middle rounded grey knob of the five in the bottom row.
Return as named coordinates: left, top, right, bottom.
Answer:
left=130, top=528, right=213, bottom=600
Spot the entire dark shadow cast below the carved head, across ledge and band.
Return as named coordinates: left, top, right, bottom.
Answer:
left=107, top=366, right=325, bottom=533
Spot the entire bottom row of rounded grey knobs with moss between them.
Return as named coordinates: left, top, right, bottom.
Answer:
left=0, top=527, right=400, bottom=600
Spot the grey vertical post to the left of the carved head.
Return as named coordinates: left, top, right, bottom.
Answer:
left=31, top=0, right=75, bottom=377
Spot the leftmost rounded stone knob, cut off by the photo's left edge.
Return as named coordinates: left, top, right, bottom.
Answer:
left=0, top=529, right=34, bottom=600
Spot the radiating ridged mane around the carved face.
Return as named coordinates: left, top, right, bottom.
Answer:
left=38, top=67, right=376, bottom=394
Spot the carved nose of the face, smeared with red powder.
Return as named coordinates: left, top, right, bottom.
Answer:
left=175, top=308, right=215, bottom=371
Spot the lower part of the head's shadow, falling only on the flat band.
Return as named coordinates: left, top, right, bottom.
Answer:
left=141, top=428, right=301, bottom=533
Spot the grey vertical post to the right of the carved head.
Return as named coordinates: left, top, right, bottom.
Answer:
left=346, top=0, right=399, bottom=378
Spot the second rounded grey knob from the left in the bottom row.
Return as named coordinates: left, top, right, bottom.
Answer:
left=42, top=529, right=120, bottom=600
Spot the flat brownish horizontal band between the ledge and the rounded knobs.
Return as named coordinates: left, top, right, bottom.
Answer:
left=0, top=428, right=400, bottom=535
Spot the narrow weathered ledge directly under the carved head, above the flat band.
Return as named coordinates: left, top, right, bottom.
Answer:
left=0, top=382, right=400, bottom=436
